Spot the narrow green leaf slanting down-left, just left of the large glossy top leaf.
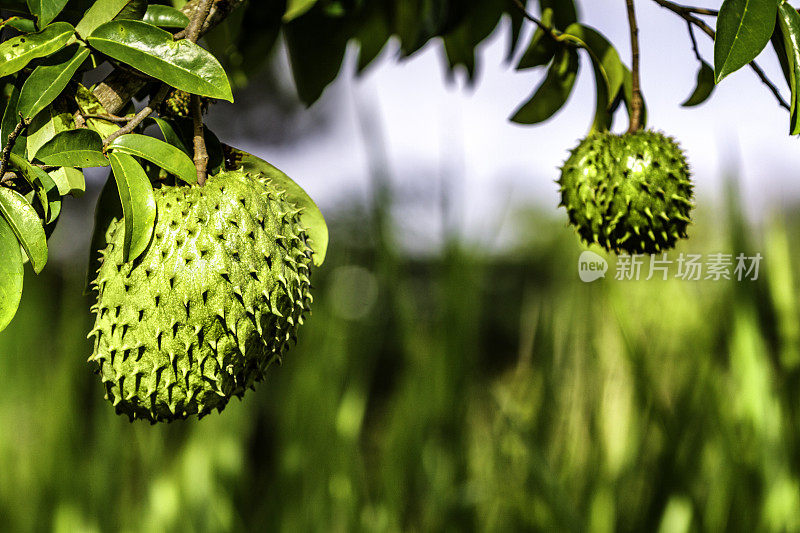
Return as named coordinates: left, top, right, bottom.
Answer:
left=17, top=44, right=89, bottom=118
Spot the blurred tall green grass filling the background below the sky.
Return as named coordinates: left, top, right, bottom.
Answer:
left=0, top=177, right=800, bottom=532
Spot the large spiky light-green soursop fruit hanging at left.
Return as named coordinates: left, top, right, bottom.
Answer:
left=89, top=171, right=312, bottom=423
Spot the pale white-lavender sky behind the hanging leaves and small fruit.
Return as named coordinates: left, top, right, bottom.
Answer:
left=216, top=0, right=800, bottom=245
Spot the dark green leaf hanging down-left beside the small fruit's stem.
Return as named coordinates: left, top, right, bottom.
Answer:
left=511, top=48, right=579, bottom=124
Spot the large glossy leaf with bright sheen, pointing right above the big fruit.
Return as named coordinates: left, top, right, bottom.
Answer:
left=88, top=20, right=233, bottom=102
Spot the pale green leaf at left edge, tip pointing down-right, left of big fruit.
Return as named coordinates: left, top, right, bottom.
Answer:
left=0, top=187, right=47, bottom=274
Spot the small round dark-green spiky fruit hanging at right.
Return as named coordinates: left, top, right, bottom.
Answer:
left=558, top=131, right=693, bottom=254
